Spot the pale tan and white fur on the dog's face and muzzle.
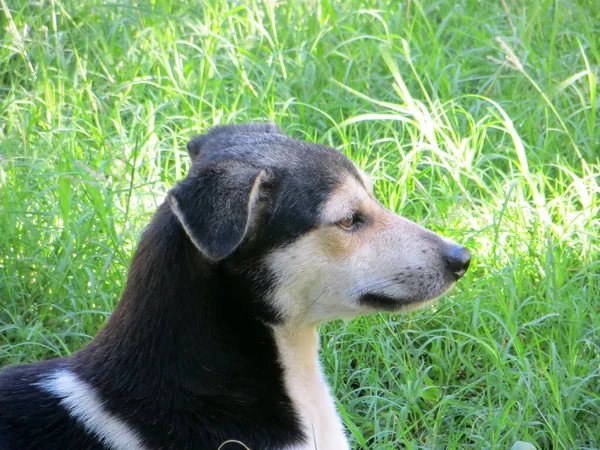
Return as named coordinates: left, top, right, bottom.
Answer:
left=269, top=175, right=460, bottom=324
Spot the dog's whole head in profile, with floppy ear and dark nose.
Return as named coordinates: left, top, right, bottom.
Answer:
left=169, top=124, right=470, bottom=324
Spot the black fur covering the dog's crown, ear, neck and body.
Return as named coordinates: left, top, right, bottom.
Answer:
left=0, top=124, right=358, bottom=450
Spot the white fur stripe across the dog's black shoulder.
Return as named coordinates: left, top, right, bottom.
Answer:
left=36, top=369, right=145, bottom=450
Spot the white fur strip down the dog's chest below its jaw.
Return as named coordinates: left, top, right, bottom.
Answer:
left=275, top=328, right=350, bottom=450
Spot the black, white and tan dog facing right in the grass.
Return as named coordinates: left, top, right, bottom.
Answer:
left=0, top=124, right=470, bottom=450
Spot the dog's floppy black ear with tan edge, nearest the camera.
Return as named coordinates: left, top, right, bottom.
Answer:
left=168, top=161, right=265, bottom=261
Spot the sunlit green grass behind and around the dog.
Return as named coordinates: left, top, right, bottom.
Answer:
left=0, top=0, right=600, bottom=449
